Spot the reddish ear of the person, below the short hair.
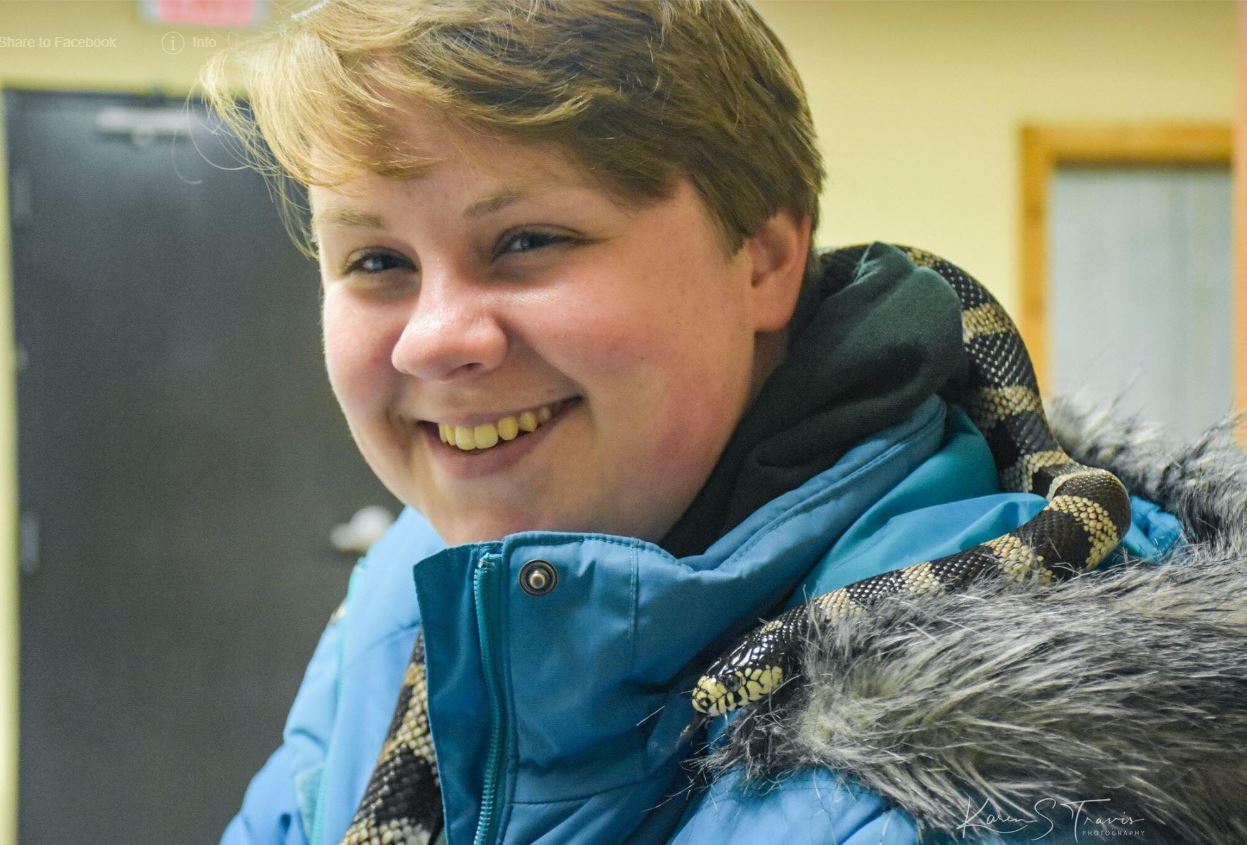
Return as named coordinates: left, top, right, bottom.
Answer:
left=744, top=211, right=811, bottom=332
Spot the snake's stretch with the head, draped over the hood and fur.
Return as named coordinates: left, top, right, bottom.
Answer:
left=692, top=247, right=1130, bottom=724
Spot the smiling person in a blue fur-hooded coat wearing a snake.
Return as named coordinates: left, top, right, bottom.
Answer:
left=206, top=0, right=1247, bottom=845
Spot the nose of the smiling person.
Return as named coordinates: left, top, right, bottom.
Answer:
left=390, top=261, right=509, bottom=381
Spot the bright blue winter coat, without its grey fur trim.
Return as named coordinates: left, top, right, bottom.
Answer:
left=222, top=398, right=1182, bottom=845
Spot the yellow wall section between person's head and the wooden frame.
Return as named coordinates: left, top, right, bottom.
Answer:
left=758, top=0, right=1237, bottom=312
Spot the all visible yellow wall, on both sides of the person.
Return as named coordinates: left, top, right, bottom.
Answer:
left=0, top=0, right=1236, bottom=843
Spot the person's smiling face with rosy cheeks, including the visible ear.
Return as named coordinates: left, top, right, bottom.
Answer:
left=311, top=115, right=808, bottom=543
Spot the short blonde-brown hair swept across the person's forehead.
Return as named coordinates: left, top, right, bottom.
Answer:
left=201, top=0, right=823, bottom=252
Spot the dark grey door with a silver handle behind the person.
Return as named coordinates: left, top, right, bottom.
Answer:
left=5, top=91, right=394, bottom=845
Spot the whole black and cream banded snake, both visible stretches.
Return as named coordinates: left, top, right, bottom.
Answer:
left=342, top=241, right=1130, bottom=845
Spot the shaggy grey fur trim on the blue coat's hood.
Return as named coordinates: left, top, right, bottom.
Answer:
left=703, top=401, right=1247, bottom=844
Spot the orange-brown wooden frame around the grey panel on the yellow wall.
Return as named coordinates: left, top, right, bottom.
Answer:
left=1018, top=123, right=1232, bottom=410
